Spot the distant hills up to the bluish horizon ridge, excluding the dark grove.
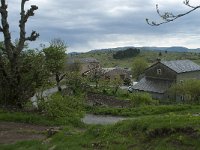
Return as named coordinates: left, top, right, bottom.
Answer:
left=68, top=47, right=200, bottom=68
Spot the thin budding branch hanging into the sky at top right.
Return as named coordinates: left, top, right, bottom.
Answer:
left=146, top=0, right=200, bottom=26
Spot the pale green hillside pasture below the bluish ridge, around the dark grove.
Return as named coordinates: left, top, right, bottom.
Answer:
left=72, top=51, right=200, bottom=67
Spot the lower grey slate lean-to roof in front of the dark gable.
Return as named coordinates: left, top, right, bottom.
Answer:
left=132, top=77, right=172, bottom=93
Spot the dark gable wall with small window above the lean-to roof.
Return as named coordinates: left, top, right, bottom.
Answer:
left=145, top=63, right=176, bottom=81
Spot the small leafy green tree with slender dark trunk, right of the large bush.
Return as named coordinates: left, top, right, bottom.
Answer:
left=43, top=39, right=67, bottom=91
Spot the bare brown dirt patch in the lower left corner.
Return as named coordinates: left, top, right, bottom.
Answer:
left=0, top=122, right=49, bottom=144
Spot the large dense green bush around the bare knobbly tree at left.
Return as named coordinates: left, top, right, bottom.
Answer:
left=0, top=50, right=48, bottom=107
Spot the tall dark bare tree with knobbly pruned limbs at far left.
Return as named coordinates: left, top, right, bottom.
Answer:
left=0, top=0, right=39, bottom=107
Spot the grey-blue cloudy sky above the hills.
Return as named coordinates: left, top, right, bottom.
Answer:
left=0, top=0, right=200, bottom=52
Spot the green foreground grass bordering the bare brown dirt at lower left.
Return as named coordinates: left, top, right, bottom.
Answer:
left=0, top=105, right=200, bottom=150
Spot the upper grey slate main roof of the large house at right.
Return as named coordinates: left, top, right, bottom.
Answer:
left=161, top=60, right=200, bottom=73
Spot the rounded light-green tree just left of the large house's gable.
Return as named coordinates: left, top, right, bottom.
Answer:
left=132, top=58, right=148, bottom=79
